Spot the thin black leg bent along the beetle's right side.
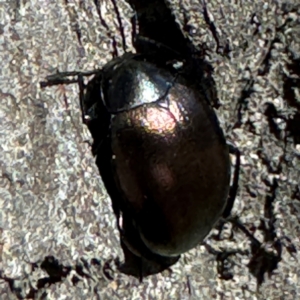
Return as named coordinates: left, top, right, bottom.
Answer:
left=223, top=143, right=241, bottom=219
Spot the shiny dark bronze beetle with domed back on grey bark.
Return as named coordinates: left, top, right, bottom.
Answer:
left=41, top=47, right=238, bottom=278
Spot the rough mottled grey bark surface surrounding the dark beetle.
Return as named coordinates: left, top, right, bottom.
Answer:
left=0, top=0, right=300, bottom=300
